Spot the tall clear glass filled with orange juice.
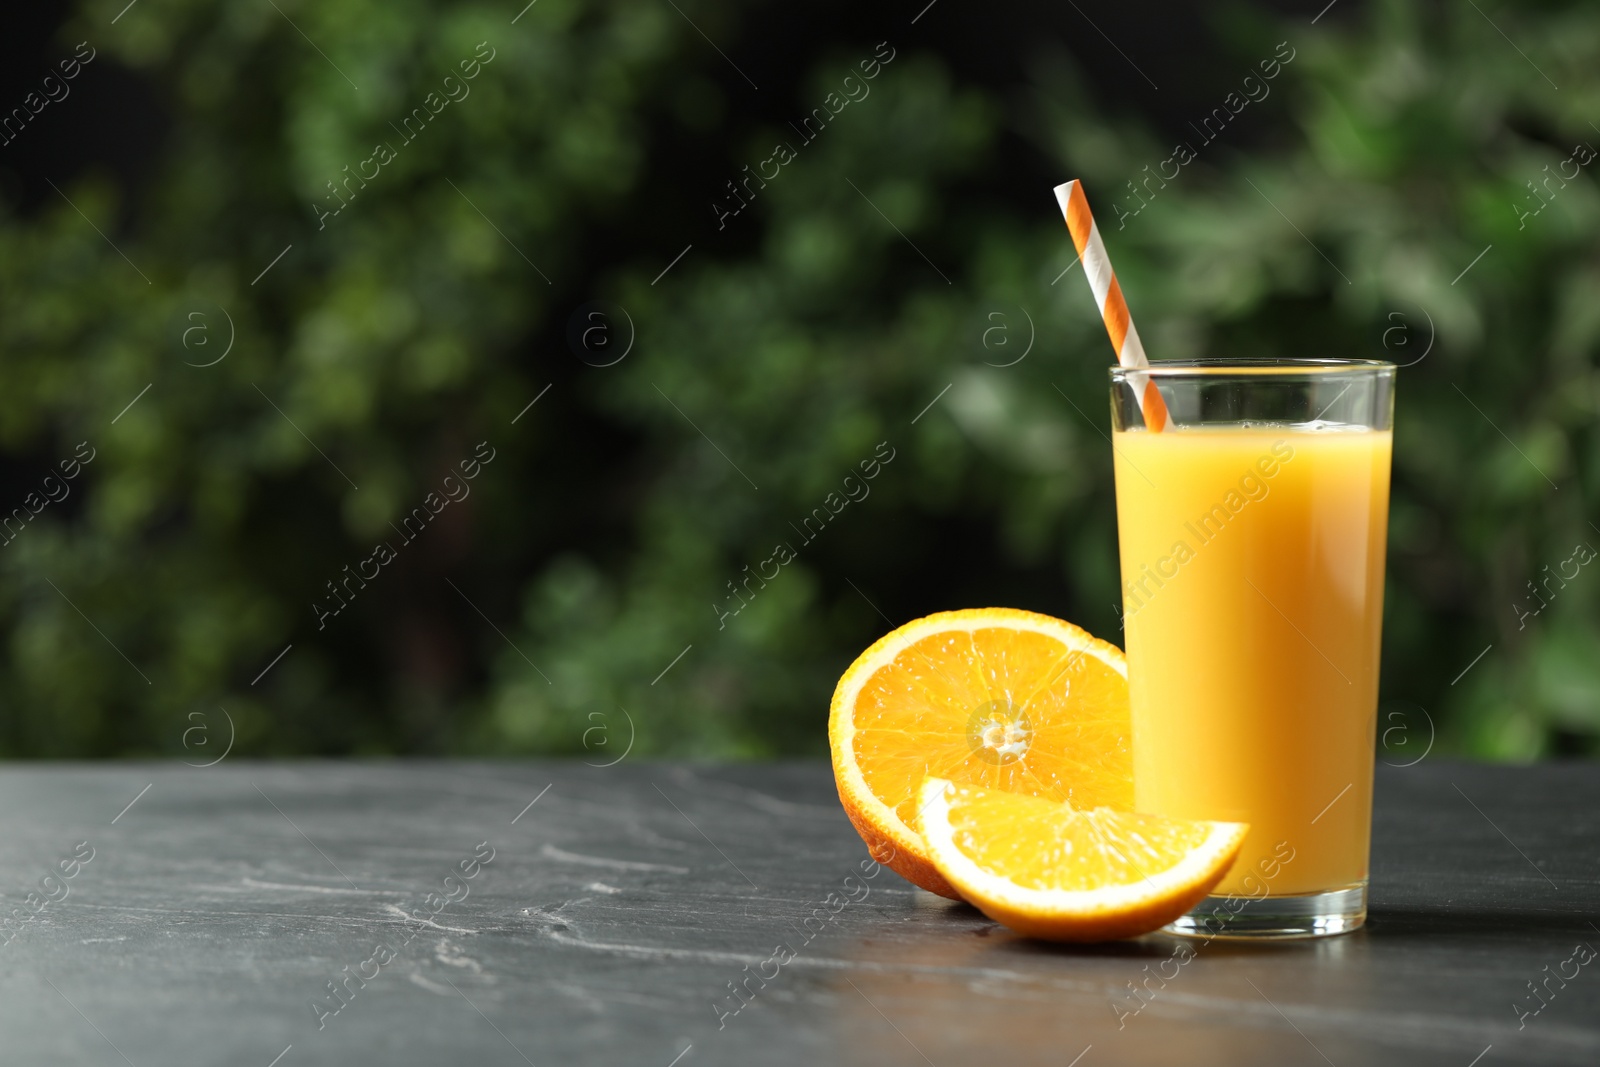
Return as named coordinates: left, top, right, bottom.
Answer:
left=1110, top=360, right=1395, bottom=937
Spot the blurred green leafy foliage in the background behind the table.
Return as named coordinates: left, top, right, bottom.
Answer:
left=0, top=0, right=1600, bottom=758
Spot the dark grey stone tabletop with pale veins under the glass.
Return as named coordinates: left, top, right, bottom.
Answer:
left=0, top=760, right=1600, bottom=1067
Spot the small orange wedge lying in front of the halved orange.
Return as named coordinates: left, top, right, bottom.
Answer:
left=918, top=777, right=1250, bottom=941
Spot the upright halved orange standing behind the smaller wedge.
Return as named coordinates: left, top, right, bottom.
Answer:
left=827, top=608, right=1133, bottom=901
